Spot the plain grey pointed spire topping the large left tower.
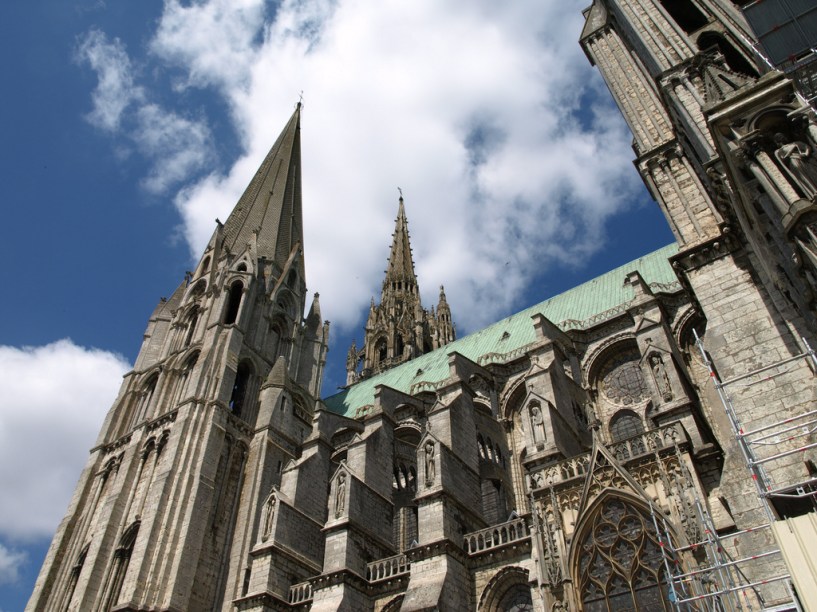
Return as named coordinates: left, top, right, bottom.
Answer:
left=224, top=102, right=303, bottom=267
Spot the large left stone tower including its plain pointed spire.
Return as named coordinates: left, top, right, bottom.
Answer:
left=27, top=104, right=329, bottom=611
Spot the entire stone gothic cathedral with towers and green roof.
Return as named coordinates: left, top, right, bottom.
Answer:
left=27, top=0, right=817, bottom=612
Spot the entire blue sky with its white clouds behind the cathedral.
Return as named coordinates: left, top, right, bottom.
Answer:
left=0, top=0, right=672, bottom=611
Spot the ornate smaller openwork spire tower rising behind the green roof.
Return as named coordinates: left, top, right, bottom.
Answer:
left=346, top=195, right=455, bottom=385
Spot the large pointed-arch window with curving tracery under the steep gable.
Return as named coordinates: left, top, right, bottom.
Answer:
left=576, top=497, right=671, bottom=612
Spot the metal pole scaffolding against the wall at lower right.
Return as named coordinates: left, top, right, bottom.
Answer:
left=653, top=333, right=817, bottom=612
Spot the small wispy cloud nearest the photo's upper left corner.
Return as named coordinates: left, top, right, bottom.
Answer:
left=76, top=30, right=142, bottom=131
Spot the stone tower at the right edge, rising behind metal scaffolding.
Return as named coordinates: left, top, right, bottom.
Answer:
left=581, top=0, right=817, bottom=604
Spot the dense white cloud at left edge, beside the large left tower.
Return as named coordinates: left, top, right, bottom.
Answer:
left=0, top=340, right=130, bottom=540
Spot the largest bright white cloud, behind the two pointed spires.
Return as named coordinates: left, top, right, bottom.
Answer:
left=151, top=0, right=641, bottom=329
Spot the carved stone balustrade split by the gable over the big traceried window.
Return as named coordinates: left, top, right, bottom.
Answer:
left=528, top=424, right=687, bottom=490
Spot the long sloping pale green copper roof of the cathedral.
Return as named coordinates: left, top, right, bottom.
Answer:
left=324, top=244, right=681, bottom=417
